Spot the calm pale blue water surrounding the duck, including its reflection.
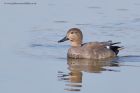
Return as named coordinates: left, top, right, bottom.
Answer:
left=0, top=0, right=140, bottom=93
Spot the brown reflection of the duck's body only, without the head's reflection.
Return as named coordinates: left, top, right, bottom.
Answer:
left=67, top=59, right=119, bottom=73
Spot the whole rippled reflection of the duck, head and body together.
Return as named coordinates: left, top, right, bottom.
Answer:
left=58, top=58, right=119, bottom=91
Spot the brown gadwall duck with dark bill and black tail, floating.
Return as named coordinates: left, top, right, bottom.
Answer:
left=58, top=28, right=122, bottom=59
